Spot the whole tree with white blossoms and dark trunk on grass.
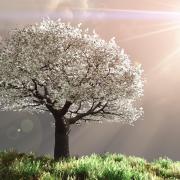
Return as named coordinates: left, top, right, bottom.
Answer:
left=0, top=19, right=143, bottom=159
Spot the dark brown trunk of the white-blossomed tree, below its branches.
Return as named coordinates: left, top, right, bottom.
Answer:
left=54, top=117, right=70, bottom=160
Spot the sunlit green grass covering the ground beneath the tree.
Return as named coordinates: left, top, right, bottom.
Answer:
left=0, top=151, right=180, bottom=180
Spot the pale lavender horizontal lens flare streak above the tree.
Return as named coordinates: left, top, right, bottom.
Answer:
left=0, top=8, right=180, bottom=21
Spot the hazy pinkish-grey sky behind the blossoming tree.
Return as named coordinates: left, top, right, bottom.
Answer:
left=0, top=0, right=180, bottom=160
